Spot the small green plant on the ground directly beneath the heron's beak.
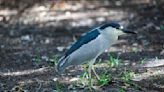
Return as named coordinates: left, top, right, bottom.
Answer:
left=121, top=70, right=134, bottom=82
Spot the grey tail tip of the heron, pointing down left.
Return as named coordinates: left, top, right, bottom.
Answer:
left=56, top=56, right=68, bottom=73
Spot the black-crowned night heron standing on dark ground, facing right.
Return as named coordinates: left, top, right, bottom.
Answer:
left=57, top=22, right=135, bottom=78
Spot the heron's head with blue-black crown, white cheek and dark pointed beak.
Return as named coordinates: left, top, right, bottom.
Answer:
left=99, top=22, right=136, bottom=36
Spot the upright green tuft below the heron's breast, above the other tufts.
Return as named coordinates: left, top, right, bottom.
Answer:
left=108, top=55, right=120, bottom=67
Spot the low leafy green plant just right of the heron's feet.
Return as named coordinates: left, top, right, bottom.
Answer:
left=97, top=73, right=111, bottom=86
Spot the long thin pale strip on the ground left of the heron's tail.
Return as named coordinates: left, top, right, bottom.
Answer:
left=0, top=67, right=49, bottom=76
